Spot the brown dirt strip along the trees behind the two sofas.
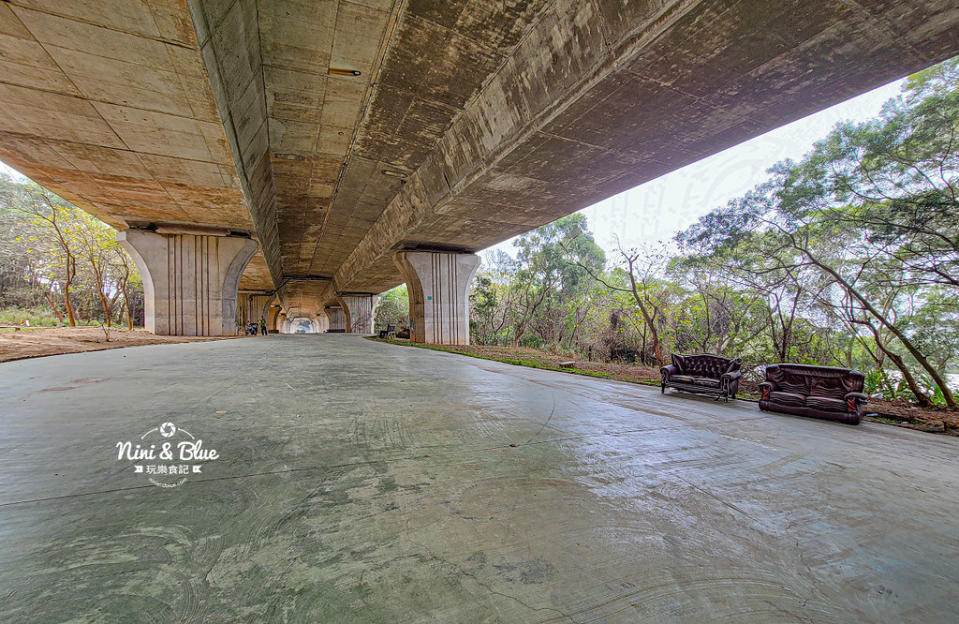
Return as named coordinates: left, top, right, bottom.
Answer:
left=380, top=340, right=959, bottom=436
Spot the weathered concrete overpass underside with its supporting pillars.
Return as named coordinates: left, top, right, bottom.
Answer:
left=0, top=0, right=959, bottom=342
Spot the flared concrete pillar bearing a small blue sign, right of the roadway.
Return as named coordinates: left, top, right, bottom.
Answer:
left=393, top=251, right=480, bottom=345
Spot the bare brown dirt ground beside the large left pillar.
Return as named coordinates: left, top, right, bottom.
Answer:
left=0, top=327, right=232, bottom=362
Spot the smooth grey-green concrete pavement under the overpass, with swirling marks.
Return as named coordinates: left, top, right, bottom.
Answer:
left=0, top=335, right=959, bottom=624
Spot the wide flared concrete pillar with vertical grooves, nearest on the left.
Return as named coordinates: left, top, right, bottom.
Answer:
left=117, top=230, right=257, bottom=336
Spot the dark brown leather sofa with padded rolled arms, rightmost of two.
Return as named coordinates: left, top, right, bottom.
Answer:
left=759, top=364, right=869, bottom=425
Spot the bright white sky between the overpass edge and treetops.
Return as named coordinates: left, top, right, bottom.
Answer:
left=0, top=80, right=902, bottom=256
